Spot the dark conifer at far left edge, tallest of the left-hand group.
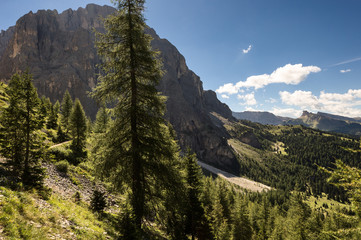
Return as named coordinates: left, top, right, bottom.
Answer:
left=0, top=72, right=45, bottom=187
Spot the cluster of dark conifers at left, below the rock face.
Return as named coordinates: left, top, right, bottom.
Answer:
left=0, top=71, right=89, bottom=189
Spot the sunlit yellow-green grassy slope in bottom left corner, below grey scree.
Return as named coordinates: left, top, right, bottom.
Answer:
left=0, top=187, right=114, bottom=239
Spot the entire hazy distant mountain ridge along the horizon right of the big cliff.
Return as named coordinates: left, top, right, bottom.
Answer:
left=232, top=111, right=361, bottom=135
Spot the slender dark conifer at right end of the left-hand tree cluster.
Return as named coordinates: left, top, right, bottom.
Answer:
left=69, top=99, right=87, bottom=164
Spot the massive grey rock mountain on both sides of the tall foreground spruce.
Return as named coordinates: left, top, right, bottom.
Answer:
left=0, top=4, right=239, bottom=174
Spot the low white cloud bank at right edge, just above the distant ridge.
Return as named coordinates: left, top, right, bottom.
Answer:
left=279, top=89, right=361, bottom=117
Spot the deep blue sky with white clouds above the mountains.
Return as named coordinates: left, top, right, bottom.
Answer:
left=0, top=0, right=361, bottom=117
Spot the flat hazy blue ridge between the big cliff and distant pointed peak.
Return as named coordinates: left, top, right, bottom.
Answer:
left=232, top=111, right=291, bottom=125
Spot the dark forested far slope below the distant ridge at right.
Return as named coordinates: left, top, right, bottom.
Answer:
left=231, top=120, right=361, bottom=202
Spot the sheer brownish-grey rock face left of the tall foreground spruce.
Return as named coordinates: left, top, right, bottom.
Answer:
left=0, top=4, right=114, bottom=115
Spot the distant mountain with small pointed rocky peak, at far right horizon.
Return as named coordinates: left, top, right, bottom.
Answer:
left=285, top=111, right=361, bottom=135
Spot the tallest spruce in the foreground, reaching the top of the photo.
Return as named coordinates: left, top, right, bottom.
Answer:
left=93, top=0, right=183, bottom=234
